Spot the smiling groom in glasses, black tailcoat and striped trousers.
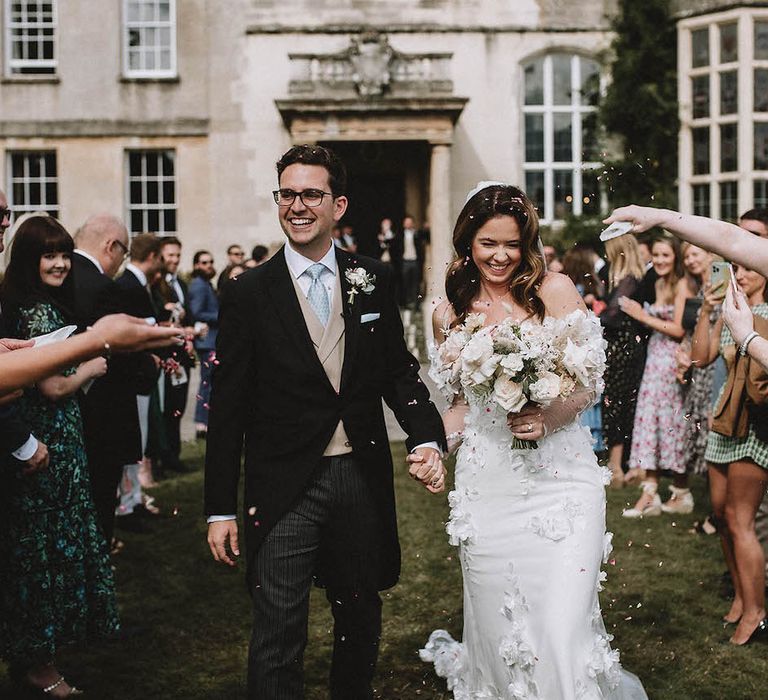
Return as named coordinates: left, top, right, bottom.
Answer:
left=205, top=146, right=445, bottom=700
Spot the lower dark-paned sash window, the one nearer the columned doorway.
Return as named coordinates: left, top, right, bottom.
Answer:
left=126, top=151, right=176, bottom=233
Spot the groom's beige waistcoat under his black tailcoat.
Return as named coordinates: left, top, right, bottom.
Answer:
left=291, top=270, right=352, bottom=457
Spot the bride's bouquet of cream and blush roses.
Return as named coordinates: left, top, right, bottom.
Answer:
left=429, top=311, right=605, bottom=449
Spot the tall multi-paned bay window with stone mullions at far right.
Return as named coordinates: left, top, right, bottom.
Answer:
left=680, top=8, right=768, bottom=221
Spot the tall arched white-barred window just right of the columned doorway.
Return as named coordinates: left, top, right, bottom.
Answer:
left=523, top=53, right=600, bottom=223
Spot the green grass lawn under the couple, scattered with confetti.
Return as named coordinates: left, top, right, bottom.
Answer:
left=0, top=444, right=768, bottom=700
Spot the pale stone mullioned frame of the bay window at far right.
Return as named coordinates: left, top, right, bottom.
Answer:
left=678, top=7, right=768, bottom=221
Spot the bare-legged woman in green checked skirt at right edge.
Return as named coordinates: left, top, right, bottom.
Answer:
left=691, top=265, right=768, bottom=645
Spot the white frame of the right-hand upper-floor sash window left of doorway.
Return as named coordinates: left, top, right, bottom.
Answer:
left=122, top=0, right=178, bottom=80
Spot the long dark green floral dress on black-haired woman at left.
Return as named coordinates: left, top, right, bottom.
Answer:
left=0, top=303, right=119, bottom=665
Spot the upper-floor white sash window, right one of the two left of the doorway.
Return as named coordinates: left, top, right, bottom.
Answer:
left=123, top=0, right=176, bottom=78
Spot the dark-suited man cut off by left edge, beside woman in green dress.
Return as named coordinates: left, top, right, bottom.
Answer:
left=0, top=190, right=48, bottom=473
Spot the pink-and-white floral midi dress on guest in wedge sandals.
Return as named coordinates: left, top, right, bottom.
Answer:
left=629, top=304, right=688, bottom=474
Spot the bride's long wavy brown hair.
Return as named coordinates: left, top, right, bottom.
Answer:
left=445, top=185, right=546, bottom=325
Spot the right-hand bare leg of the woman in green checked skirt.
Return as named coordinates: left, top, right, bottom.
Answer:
left=725, top=462, right=768, bottom=644
